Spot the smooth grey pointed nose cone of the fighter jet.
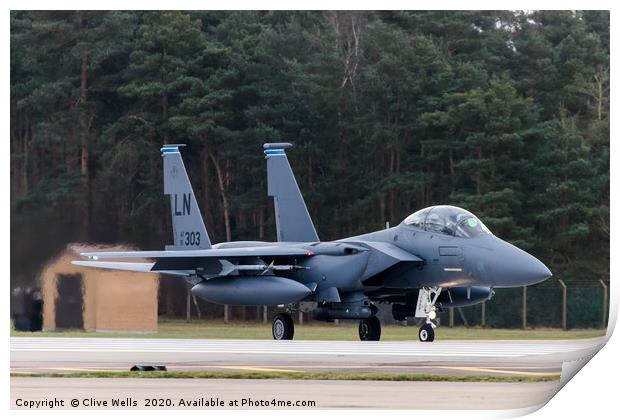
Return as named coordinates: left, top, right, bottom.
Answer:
left=494, top=241, right=553, bottom=287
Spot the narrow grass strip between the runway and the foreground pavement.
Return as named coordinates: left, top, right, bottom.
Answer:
left=11, top=371, right=560, bottom=382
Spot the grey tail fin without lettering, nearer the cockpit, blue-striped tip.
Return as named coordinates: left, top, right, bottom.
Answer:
left=263, top=143, right=319, bottom=242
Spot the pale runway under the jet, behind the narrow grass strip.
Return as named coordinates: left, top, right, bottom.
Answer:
left=11, top=337, right=604, bottom=375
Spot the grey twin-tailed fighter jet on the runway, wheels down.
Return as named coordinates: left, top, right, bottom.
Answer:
left=73, top=143, right=552, bottom=342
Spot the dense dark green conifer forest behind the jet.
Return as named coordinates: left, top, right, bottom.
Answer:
left=10, top=11, right=610, bottom=284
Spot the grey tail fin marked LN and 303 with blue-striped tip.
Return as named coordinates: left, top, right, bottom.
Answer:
left=161, top=144, right=211, bottom=250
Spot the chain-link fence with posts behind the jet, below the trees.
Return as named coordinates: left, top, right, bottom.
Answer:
left=160, top=279, right=609, bottom=329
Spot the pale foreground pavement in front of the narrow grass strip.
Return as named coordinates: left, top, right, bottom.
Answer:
left=11, top=378, right=558, bottom=410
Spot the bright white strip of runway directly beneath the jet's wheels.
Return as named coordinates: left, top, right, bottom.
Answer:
left=11, top=337, right=604, bottom=358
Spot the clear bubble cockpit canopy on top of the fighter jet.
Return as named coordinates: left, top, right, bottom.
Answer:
left=403, top=206, right=492, bottom=238
